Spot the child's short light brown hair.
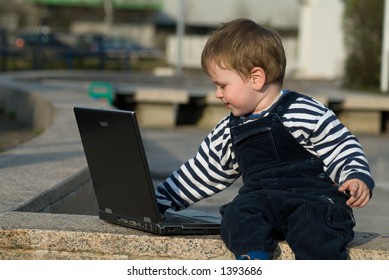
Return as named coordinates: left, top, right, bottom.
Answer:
left=201, top=19, right=286, bottom=85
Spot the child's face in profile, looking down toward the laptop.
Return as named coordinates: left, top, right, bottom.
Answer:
left=209, top=65, right=261, bottom=117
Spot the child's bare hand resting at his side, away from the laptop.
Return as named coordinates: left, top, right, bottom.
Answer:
left=338, top=179, right=370, bottom=208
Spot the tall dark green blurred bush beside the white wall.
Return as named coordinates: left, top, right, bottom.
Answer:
left=343, top=0, right=385, bottom=89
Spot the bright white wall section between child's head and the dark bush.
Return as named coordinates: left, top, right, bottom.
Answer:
left=296, top=0, right=345, bottom=79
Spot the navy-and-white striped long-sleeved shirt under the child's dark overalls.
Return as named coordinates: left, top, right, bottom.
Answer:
left=156, top=91, right=374, bottom=211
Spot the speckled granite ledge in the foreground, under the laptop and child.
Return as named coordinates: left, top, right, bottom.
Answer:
left=0, top=212, right=389, bottom=260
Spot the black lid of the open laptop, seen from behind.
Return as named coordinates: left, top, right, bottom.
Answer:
left=74, top=107, right=161, bottom=222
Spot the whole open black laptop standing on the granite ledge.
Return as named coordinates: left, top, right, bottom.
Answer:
left=74, top=107, right=221, bottom=235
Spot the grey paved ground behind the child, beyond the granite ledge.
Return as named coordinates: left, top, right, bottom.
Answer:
left=142, top=127, right=389, bottom=233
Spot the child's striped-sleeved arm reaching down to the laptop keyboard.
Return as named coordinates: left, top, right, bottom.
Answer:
left=156, top=118, right=240, bottom=213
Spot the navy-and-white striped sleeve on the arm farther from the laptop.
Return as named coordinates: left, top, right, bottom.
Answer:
left=283, top=94, right=374, bottom=190
